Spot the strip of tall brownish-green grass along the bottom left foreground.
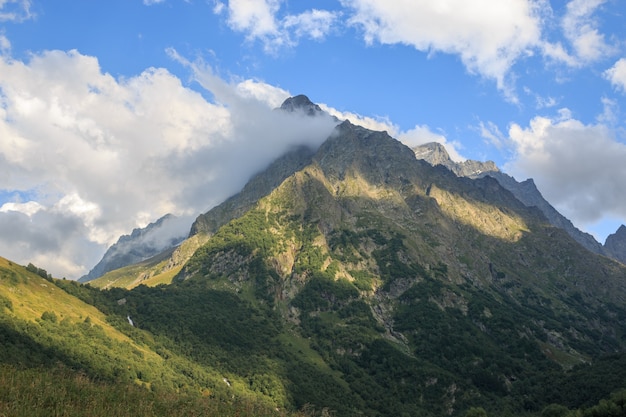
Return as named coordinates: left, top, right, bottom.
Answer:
left=0, top=365, right=324, bottom=417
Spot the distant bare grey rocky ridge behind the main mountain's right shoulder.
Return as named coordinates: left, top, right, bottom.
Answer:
left=413, top=142, right=608, bottom=260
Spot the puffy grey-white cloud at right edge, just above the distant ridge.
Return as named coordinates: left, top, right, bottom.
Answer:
left=504, top=109, right=626, bottom=226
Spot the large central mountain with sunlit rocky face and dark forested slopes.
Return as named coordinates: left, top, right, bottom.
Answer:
left=167, top=109, right=626, bottom=415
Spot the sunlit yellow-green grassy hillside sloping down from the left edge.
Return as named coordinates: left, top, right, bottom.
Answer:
left=0, top=258, right=310, bottom=416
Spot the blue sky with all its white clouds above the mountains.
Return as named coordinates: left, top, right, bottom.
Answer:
left=0, top=0, right=626, bottom=278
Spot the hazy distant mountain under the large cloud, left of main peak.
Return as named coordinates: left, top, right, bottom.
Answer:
left=78, top=214, right=189, bottom=282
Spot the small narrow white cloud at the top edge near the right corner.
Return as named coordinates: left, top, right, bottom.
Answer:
left=562, top=0, right=613, bottom=64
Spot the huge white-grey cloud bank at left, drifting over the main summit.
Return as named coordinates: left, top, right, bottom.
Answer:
left=0, top=51, right=335, bottom=277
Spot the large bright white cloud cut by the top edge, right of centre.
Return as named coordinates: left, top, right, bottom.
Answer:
left=342, top=0, right=542, bottom=93
